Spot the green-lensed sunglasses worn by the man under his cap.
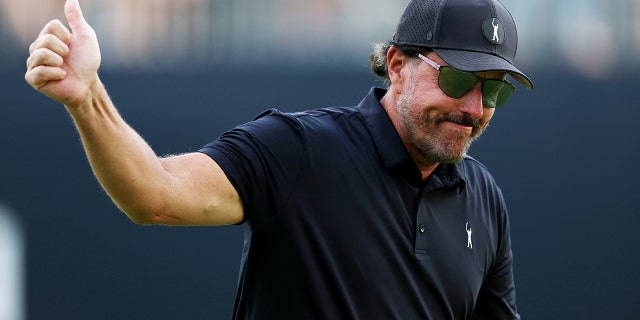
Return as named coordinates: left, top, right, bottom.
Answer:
left=418, top=53, right=516, bottom=108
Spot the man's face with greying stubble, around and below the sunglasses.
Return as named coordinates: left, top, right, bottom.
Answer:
left=396, top=53, right=500, bottom=164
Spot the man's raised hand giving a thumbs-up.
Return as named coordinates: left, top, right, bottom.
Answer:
left=25, top=0, right=100, bottom=108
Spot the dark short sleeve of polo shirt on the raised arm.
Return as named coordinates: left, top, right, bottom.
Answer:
left=199, top=109, right=305, bottom=230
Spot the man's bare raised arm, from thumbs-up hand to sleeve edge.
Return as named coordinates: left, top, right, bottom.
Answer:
left=25, top=0, right=243, bottom=225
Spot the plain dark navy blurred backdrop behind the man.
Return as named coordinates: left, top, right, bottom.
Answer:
left=0, top=67, right=640, bottom=319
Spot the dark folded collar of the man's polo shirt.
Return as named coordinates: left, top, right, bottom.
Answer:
left=358, top=88, right=466, bottom=188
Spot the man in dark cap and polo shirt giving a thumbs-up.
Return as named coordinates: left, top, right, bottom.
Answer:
left=25, top=0, right=532, bottom=319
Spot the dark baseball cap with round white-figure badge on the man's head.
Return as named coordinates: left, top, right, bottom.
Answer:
left=393, top=0, right=533, bottom=89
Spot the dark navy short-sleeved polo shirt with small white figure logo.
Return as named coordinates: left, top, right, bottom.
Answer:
left=200, top=89, right=519, bottom=320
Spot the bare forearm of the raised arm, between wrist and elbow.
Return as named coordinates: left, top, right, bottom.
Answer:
left=65, top=81, right=169, bottom=223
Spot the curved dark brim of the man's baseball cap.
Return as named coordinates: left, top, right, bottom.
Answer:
left=433, top=48, right=533, bottom=89
